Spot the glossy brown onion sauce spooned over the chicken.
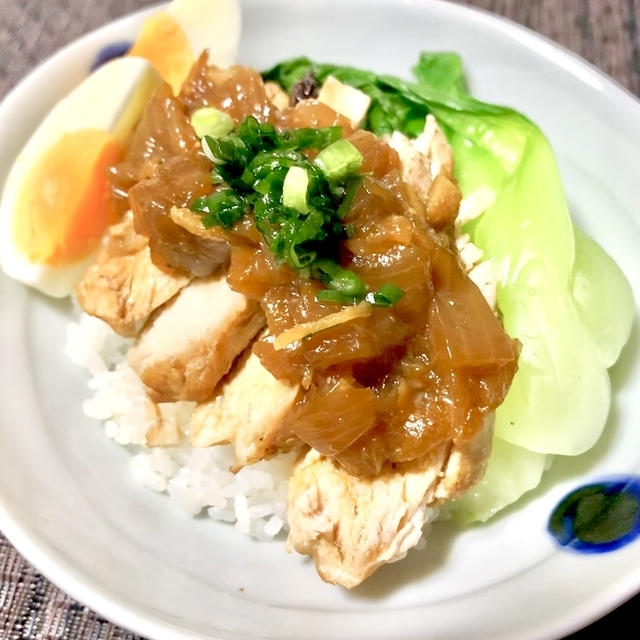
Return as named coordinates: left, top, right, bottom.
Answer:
left=112, top=57, right=518, bottom=475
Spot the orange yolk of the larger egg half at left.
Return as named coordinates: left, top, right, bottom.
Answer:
left=13, top=129, right=122, bottom=266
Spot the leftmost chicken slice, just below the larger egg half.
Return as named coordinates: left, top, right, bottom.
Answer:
left=76, top=212, right=190, bottom=337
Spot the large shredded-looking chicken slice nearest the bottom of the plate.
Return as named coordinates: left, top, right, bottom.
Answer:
left=287, top=422, right=492, bottom=589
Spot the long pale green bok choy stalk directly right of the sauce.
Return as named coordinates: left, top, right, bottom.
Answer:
left=400, top=55, right=632, bottom=455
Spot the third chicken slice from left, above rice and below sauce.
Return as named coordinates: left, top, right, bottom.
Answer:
left=190, top=340, right=299, bottom=471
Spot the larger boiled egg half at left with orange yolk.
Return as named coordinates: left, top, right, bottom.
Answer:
left=0, top=58, right=160, bottom=297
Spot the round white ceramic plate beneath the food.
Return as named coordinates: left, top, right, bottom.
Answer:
left=0, top=0, right=640, bottom=640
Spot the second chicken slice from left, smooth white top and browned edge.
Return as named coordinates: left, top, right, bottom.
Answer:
left=128, top=276, right=265, bottom=402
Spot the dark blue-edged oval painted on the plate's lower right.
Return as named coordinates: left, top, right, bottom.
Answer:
left=547, top=476, right=640, bottom=553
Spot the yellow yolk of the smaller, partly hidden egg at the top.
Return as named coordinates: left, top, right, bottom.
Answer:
left=129, top=12, right=195, bottom=94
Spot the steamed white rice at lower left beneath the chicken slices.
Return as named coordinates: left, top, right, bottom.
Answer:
left=67, top=312, right=296, bottom=540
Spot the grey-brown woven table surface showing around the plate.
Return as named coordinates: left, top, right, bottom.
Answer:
left=0, top=0, right=640, bottom=640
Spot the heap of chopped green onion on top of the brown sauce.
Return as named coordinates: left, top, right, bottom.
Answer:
left=191, top=116, right=378, bottom=294
